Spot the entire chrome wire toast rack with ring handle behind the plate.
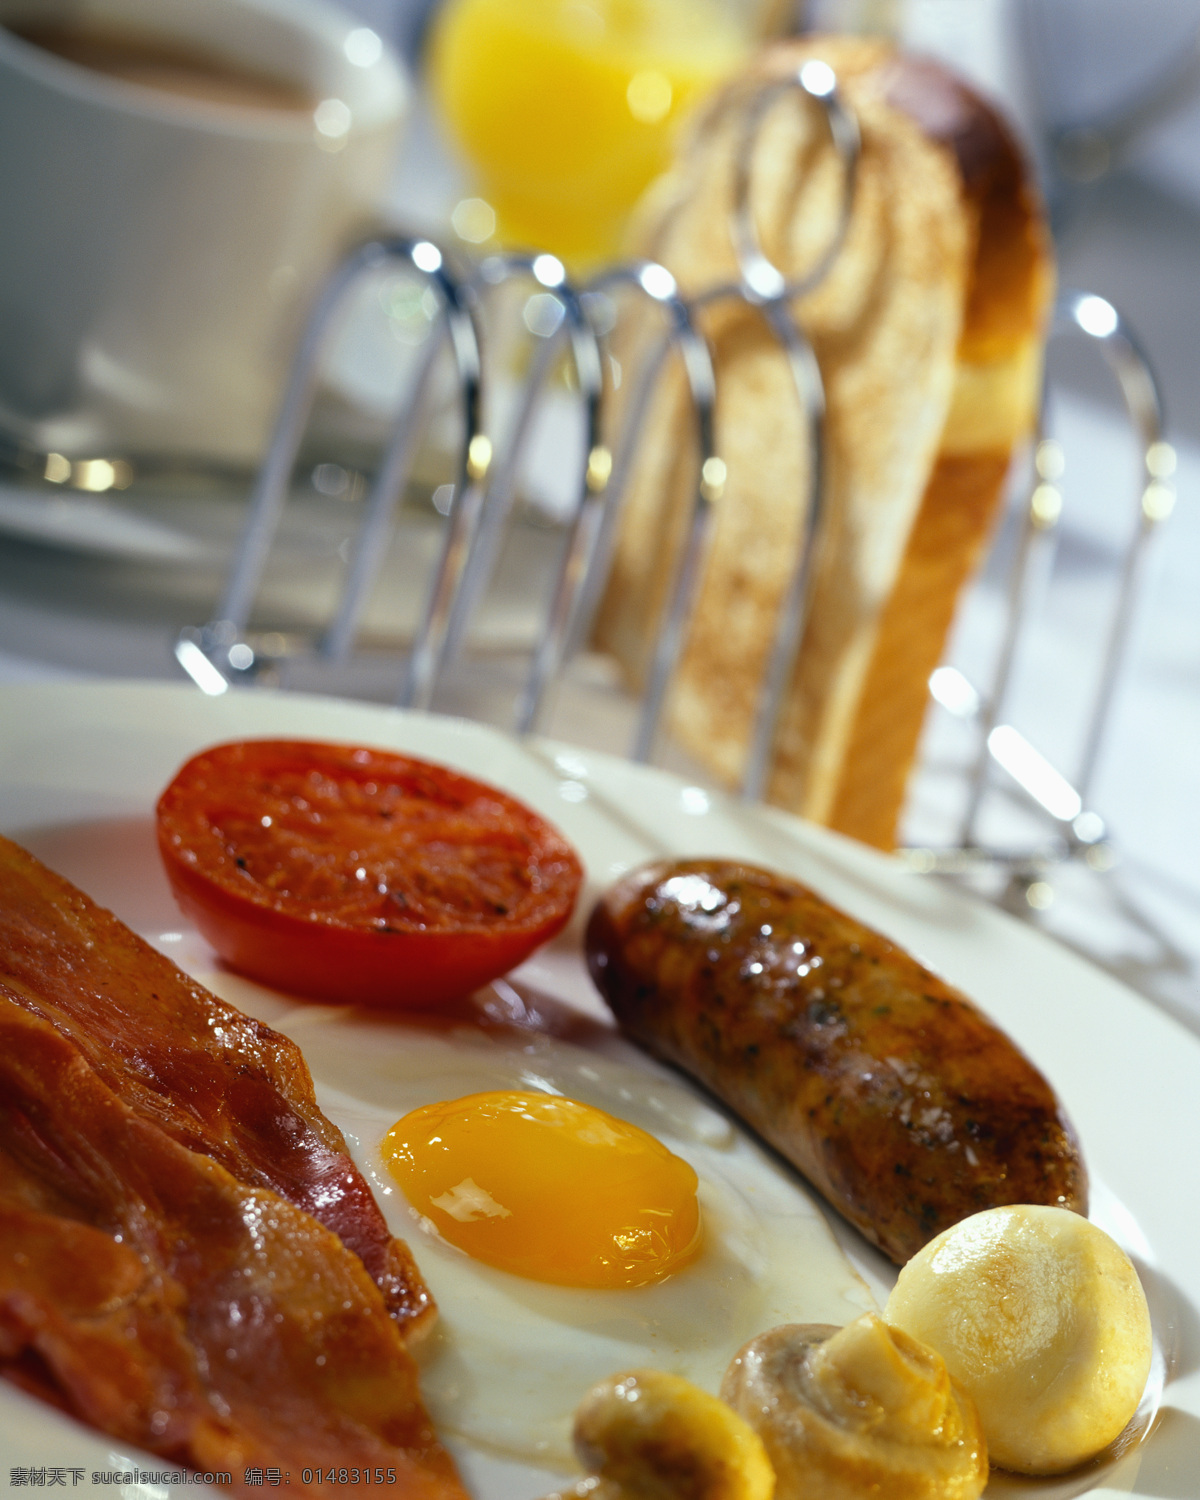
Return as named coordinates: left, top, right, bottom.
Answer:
left=176, top=60, right=1175, bottom=905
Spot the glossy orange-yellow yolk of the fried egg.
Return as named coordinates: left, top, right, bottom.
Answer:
left=383, top=1092, right=701, bottom=1287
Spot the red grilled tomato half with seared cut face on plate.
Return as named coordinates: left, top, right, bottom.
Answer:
left=158, top=740, right=582, bottom=1007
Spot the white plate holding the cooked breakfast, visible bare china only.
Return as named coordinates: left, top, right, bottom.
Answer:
left=0, top=684, right=1200, bottom=1500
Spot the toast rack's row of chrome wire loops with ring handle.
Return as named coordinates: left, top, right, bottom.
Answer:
left=176, top=62, right=860, bottom=798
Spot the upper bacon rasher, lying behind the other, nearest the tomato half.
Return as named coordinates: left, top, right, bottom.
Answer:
left=0, top=839, right=435, bottom=1338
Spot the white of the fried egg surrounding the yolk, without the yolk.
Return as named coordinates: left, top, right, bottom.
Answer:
left=218, top=975, right=875, bottom=1473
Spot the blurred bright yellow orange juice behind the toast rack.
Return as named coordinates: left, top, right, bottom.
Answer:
left=431, top=0, right=749, bottom=266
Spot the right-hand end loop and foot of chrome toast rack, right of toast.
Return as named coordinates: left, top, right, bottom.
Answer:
left=906, top=291, right=1176, bottom=884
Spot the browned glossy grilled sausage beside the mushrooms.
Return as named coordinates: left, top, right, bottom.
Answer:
left=587, top=860, right=1088, bottom=1265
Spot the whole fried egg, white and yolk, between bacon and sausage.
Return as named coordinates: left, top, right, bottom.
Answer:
left=199, top=975, right=875, bottom=1473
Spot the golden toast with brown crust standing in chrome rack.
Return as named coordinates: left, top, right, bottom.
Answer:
left=596, top=38, right=1053, bottom=848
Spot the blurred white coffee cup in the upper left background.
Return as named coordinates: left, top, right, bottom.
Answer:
left=0, top=0, right=410, bottom=464
